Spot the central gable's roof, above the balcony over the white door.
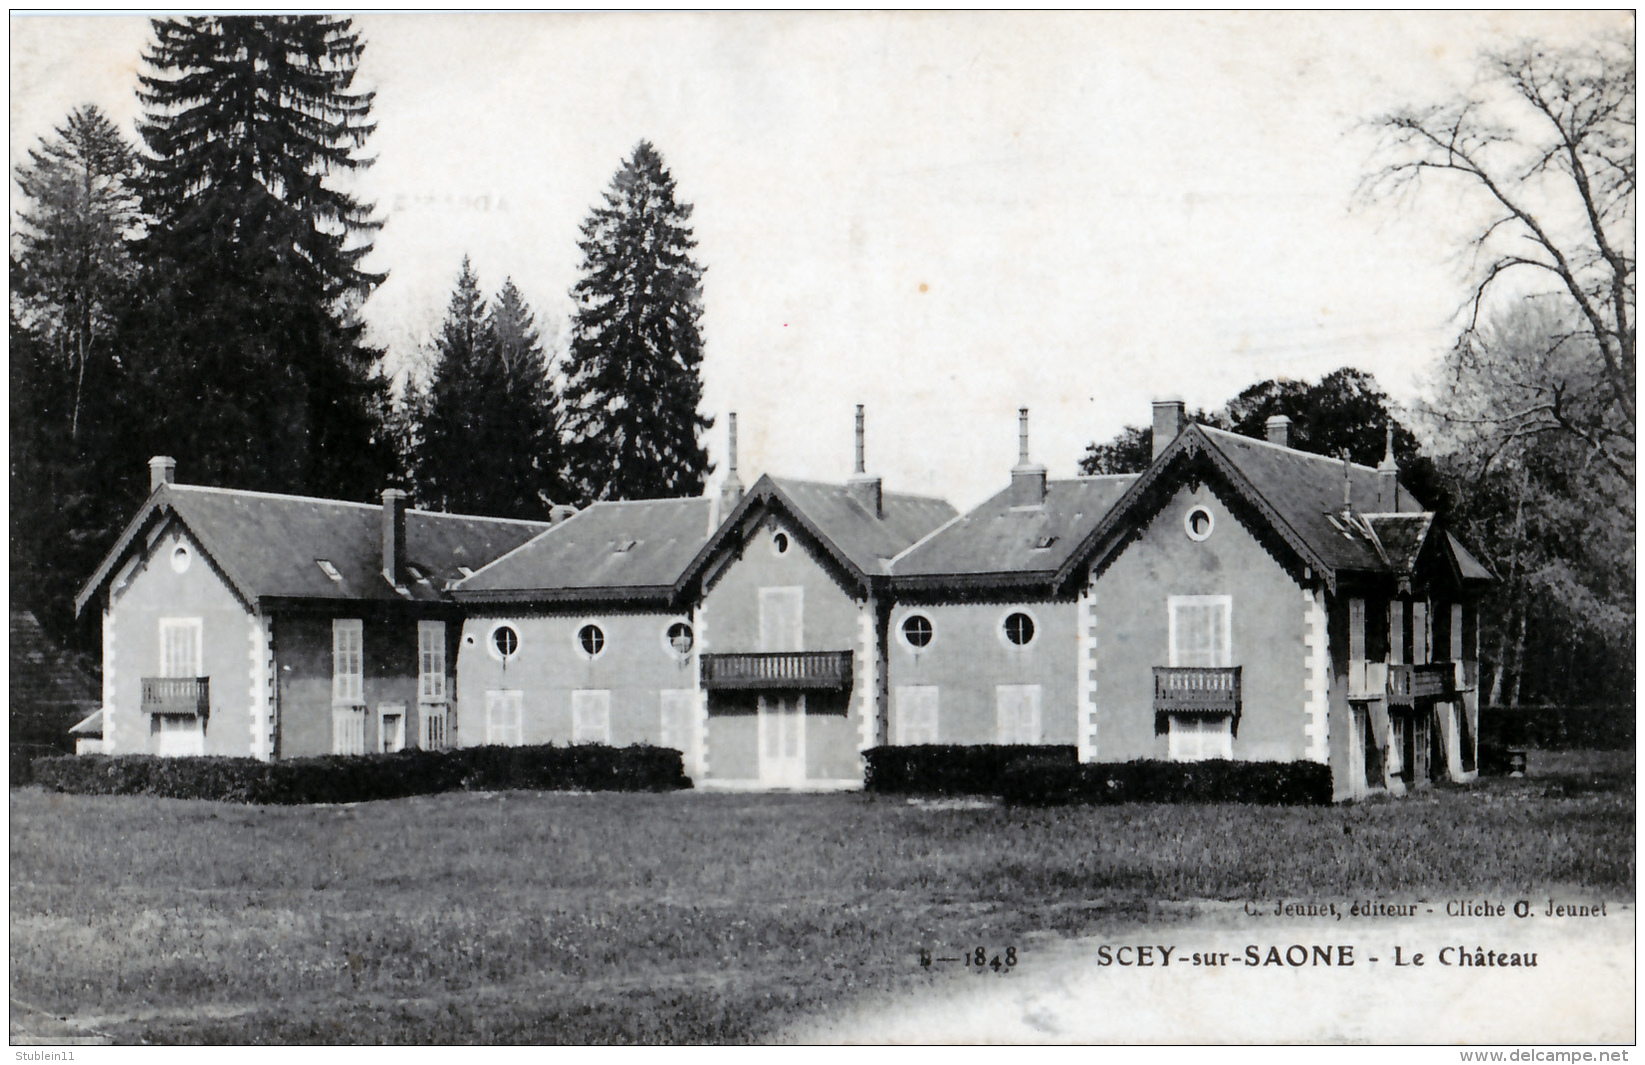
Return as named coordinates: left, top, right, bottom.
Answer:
left=681, top=474, right=957, bottom=588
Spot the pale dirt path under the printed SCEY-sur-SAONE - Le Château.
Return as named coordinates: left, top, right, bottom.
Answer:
left=786, top=897, right=1635, bottom=1044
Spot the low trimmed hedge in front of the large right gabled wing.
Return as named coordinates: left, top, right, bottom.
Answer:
left=1000, top=759, right=1331, bottom=807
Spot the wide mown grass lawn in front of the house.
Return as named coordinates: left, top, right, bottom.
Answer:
left=10, top=754, right=1635, bottom=1044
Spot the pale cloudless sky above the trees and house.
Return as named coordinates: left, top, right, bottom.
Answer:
left=10, top=12, right=1629, bottom=509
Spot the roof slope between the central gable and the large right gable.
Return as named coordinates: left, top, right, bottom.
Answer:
left=892, top=474, right=1138, bottom=588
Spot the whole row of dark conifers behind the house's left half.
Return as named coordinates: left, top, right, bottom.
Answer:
left=8, top=15, right=712, bottom=645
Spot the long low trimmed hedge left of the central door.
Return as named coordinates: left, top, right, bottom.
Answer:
left=33, top=744, right=691, bottom=805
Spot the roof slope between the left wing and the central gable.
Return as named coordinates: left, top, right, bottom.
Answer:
left=451, top=497, right=712, bottom=602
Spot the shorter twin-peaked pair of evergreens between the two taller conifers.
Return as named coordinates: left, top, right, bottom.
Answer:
left=403, top=258, right=564, bottom=519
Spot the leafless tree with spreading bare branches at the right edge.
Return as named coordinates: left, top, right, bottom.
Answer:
left=1362, top=36, right=1635, bottom=482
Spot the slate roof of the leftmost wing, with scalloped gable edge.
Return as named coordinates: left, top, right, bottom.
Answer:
left=74, top=484, right=549, bottom=611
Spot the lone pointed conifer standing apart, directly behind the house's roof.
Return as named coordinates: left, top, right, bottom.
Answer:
left=564, top=142, right=714, bottom=499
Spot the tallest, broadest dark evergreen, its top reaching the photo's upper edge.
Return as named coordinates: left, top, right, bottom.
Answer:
left=130, top=15, right=392, bottom=499
